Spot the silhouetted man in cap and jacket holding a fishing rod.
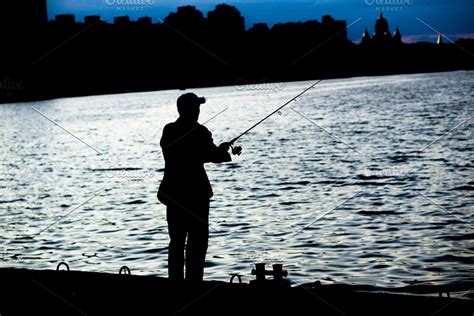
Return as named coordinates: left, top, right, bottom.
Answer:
left=158, top=93, right=232, bottom=281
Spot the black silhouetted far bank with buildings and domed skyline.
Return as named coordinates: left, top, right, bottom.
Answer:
left=0, top=0, right=474, bottom=102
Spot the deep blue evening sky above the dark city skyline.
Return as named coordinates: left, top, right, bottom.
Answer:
left=48, top=0, right=474, bottom=42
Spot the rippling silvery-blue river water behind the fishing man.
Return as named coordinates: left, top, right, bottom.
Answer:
left=0, top=72, right=474, bottom=287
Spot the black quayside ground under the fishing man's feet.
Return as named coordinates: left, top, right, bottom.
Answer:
left=0, top=269, right=474, bottom=316
